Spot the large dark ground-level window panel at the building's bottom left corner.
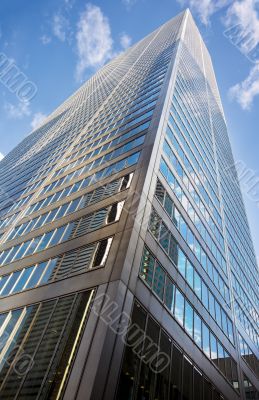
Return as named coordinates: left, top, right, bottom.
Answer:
left=0, top=291, right=93, bottom=399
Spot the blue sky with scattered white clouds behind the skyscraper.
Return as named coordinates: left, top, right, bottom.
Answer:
left=0, top=0, right=259, bottom=255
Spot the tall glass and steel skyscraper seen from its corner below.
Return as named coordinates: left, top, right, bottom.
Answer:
left=0, top=10, right=259, bottom=400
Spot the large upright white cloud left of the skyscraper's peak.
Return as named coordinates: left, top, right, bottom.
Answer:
left=76, top=3, right=113, bottom=80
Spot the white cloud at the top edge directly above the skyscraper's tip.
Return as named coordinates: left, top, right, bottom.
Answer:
left=178, top=0, right=231, bottom=25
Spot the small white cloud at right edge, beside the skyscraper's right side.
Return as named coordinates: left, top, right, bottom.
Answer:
left=229, top=64, right=259, bottom=110
